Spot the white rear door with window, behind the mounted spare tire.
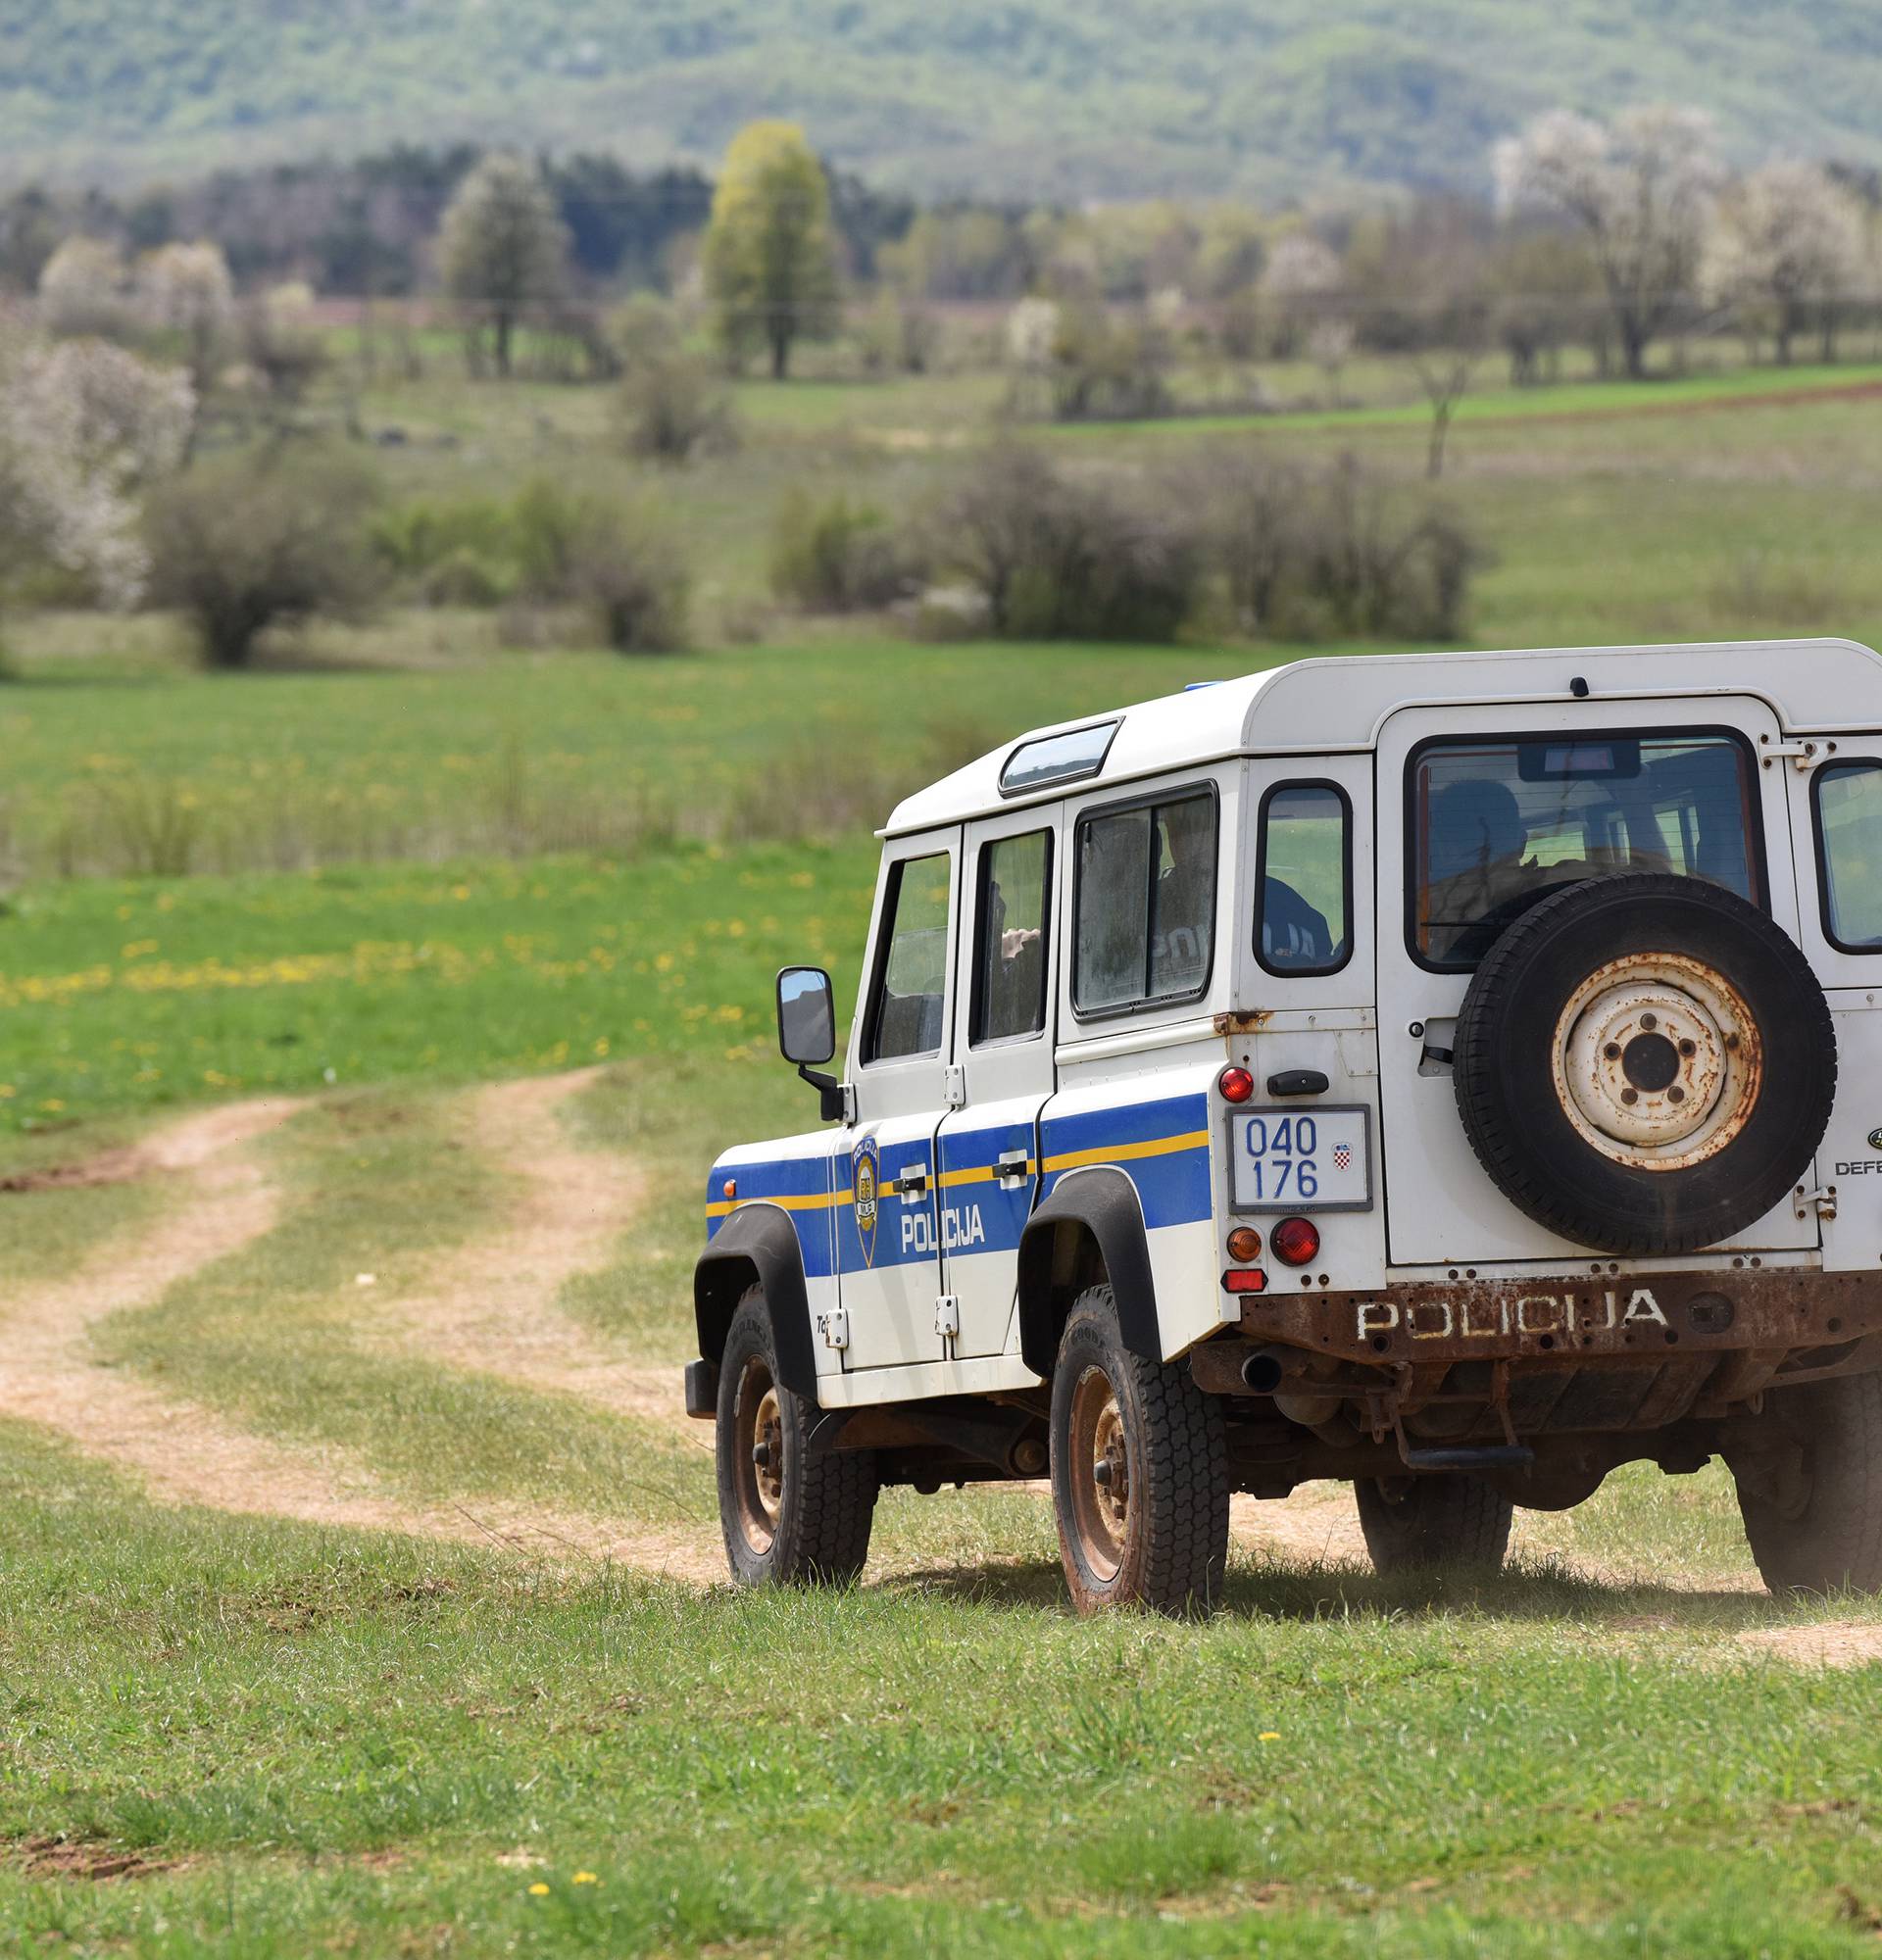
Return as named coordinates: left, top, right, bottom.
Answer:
left=1376, top=696, right=1817, bottom=1268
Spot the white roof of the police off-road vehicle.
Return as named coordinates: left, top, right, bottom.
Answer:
left=878, top=639, right=1882, bottom=837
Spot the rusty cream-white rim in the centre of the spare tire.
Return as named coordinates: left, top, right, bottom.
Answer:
left=1553, top=953, right=1760, bottom=1170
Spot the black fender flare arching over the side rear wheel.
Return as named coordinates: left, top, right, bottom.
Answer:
left=1019, top=1164, right=1163, bottom=1376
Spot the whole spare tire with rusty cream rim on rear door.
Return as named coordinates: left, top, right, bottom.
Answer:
left=1453, top=872, right=1837, bottom=1254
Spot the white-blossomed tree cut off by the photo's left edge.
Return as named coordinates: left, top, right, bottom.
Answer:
left=0, top=339, right=196, bottom=606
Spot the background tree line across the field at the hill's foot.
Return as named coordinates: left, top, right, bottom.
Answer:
left=15, top=106, right=1882, bottom=390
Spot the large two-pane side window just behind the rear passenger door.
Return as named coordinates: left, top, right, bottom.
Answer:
left=1072, top=792, right=1215, bottom=1013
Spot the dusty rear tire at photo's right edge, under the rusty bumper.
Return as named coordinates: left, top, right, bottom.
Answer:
left=1735, top=1374, right=1882, bottom=1597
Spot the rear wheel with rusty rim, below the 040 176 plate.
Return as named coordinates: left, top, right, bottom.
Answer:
left=1051, top=1286, right=1229, bottom=1613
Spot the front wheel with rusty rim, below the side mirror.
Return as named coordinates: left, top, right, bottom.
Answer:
left=718, top=1286, right=876, bottom=1586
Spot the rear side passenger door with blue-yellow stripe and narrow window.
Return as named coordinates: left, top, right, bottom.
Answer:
left=933, top=806, right=1061, bottom=1358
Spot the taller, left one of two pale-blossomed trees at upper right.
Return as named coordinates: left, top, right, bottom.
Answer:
left=1494, top=104, right=1723, bottom=380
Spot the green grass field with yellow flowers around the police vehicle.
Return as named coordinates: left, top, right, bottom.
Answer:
left=0, top=349, right=1882, bottom=1960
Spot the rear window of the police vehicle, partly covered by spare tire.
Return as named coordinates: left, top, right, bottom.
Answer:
left=1406, top=731, right=1764, bottom=972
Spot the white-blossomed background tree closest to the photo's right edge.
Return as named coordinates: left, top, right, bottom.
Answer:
left=1706, top=159, right=1866, bottom=367
